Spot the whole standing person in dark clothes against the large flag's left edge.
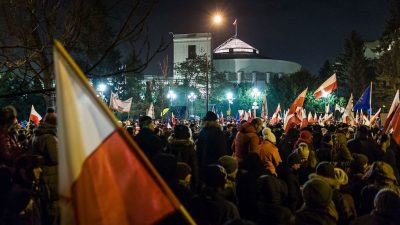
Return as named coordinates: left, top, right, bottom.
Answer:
left=31, top=108, right=60, bottom=224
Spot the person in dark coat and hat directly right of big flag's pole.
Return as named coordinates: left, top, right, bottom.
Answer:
left=134, top=116, right=164, bottom=161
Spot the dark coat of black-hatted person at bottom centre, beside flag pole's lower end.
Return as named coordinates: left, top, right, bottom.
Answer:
left=188, top=190, right=240, bottom=225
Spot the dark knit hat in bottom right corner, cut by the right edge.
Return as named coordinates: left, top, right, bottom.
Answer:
left=374, top=188, right=400, bottom=215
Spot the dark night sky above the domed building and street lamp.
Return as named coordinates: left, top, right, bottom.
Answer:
left=145, top=0, right=389, bottom=74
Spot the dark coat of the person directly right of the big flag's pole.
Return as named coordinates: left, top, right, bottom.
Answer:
left=134, top=128, right=164, bottom=161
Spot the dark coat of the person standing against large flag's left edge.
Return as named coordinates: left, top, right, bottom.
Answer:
left=32, top=122, right=58, bottom=201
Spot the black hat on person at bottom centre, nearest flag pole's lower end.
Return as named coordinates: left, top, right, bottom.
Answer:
left=204, top=164, right=227, bottom=188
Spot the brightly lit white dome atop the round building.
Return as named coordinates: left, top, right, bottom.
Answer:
left=214, top=37, right=259, bottom=55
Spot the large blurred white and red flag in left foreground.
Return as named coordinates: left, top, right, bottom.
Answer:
left=53, top=41, right=192, bottom=225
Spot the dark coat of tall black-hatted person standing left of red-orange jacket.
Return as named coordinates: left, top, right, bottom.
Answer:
left=196, top=121, right=228, bottom=170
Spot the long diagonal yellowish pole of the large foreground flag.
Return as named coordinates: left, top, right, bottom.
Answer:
left=54, top=40, right=196, bottom=225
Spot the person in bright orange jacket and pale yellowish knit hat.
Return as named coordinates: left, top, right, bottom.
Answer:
left=257, top=127, right=282, bottom=176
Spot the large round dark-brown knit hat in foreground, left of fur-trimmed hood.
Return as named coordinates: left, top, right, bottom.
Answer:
left=303, top=179, right=333, bottom=208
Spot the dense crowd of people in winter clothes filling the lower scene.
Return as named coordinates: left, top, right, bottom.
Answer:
left=0, top=104, right=400, bottom=225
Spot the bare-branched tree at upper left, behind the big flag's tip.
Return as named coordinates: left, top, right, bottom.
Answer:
left=0, top=0, right=168, bottom=106
